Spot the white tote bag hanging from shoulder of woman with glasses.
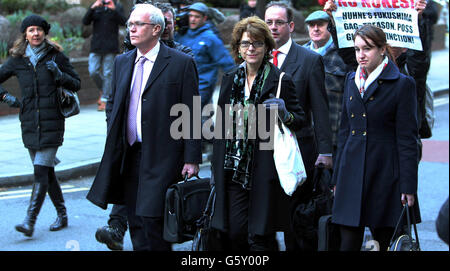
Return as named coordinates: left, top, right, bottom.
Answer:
left=273, top=72, right=306, bottom=196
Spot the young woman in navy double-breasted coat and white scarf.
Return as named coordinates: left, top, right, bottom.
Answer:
left=332, top=25, right=418, bottom=250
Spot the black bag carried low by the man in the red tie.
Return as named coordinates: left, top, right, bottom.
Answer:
left=291, top=167, right=333, bottom=251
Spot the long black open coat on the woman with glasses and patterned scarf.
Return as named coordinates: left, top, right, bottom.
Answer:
left=211, top=64, right=305, bottom=235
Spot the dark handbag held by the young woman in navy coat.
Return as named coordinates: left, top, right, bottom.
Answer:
left=388, top=204, right=420, bottom=251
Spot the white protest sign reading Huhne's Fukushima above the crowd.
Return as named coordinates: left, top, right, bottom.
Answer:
left=333, top=0, right=422, bottom=50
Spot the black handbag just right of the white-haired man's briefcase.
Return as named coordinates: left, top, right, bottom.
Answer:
left=192, top=186, right=223, bottom=251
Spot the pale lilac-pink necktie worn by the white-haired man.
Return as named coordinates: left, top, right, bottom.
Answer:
left=127, top=56, right=147, bottom=146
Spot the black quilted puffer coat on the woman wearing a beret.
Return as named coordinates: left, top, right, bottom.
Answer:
left=0, top=45, right=80, bottom=150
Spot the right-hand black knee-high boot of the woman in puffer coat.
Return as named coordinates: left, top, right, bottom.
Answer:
left=48, top=168, right=68, bottom=231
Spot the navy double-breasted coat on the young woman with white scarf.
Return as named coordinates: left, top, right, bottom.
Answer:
left=333, top=61, right=420, bottom=228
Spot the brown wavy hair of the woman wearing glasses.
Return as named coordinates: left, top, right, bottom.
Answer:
left=231, top=16, right=275, bottom=64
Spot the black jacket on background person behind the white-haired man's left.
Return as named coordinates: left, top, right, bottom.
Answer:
left=83, top=1, right=127, bottom=54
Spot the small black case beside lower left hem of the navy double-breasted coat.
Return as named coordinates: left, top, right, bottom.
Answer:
left=317, top=215, right=341, bottom=251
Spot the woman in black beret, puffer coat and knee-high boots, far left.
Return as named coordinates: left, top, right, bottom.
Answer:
left=0, top=14, right=80, bottom=237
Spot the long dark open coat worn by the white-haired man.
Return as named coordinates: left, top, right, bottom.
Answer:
left=87, top=44, right=201, bottom=217
